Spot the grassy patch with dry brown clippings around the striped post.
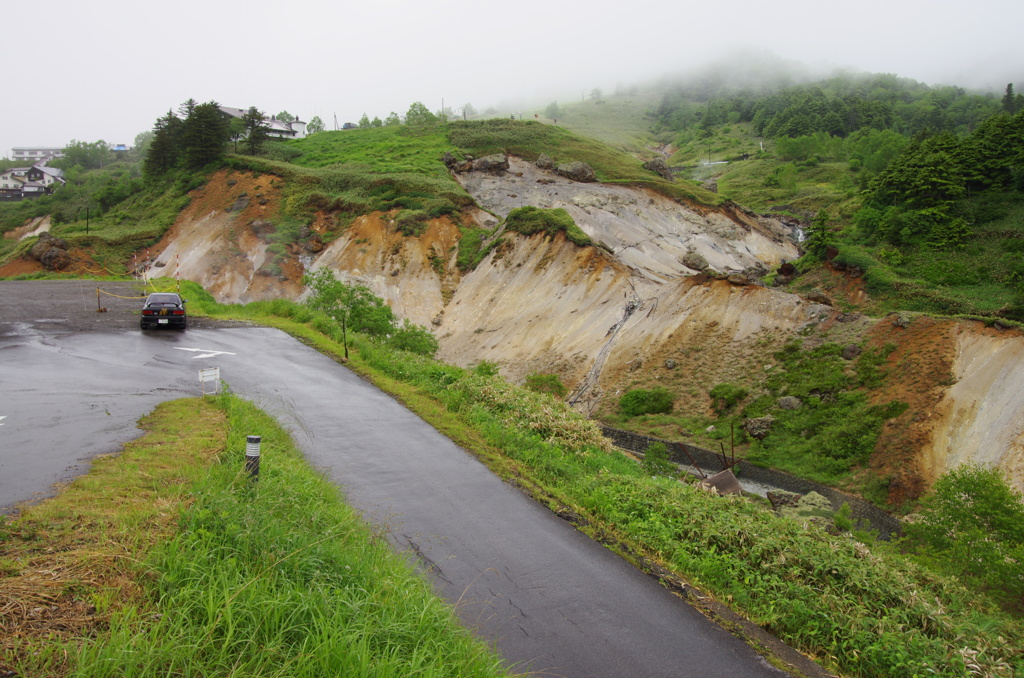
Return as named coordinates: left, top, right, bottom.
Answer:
left=0, top=396, right=506, bottom=678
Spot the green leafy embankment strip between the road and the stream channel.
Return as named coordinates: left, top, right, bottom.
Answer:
left=169, top=280, right=1024, bottom=676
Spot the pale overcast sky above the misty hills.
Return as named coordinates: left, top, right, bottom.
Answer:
left=0, top=0, right=1024, bottom=157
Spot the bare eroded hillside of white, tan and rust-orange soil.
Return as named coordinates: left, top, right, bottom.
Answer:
left=146, top=165, right=1024, bottom=503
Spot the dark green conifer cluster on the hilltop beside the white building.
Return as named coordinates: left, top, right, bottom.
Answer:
left=143, top=99, right=276, bottom=177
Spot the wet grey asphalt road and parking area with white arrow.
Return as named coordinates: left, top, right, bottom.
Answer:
left=0, top=282, right=786, bottom=678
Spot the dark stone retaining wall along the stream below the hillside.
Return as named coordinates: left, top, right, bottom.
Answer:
left=601, top=426, right=902, bottom=540
